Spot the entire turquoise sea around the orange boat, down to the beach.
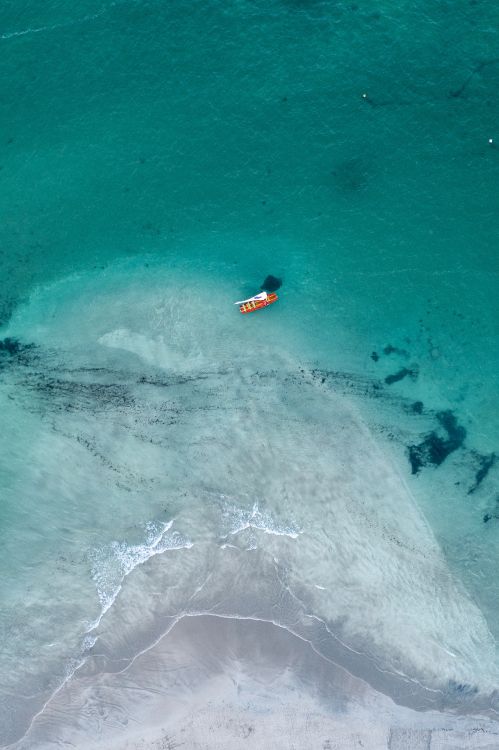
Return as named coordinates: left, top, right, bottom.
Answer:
left=0, top=0, right=499, bottom=745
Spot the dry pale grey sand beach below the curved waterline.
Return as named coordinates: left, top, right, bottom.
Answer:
left=12, top=616, right=499, bottom=750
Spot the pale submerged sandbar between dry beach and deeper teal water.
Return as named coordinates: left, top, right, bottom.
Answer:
left=2, top=268, right=498, bottom=746
